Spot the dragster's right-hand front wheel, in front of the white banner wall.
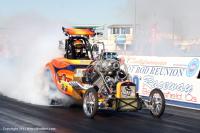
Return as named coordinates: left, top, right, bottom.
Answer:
left=149, top=89, right=165, bottom=118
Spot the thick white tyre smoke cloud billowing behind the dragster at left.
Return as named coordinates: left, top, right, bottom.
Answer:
left=0, top=14, right=71, bottom=105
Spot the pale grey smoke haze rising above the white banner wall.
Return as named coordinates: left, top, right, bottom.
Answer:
left=121, top=0, right=200, bottom=56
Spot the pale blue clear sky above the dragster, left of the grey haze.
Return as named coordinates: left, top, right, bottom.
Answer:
left=0, top=0, right=129, bottom=24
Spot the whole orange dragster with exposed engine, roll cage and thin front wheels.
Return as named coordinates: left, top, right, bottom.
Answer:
left=45, top=28, right=165, bottom=118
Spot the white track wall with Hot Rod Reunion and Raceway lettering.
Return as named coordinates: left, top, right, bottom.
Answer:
left=125, top=56, right=200, bottom=110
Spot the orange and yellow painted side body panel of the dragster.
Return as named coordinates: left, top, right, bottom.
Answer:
left=46, top=58, right=91, bottom=99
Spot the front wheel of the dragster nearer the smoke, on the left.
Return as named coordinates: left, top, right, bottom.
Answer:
left=83, top=88, right=98, bottom=119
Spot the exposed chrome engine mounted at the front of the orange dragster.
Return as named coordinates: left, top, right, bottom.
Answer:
left=85, top=53, right=128, bottom=96
